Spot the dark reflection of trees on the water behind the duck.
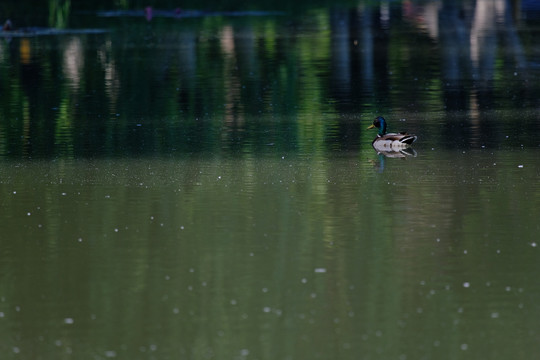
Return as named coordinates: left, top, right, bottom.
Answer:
left=0, top=0, right=540, bottom=157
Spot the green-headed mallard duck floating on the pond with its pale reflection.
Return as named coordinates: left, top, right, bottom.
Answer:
left=368, top=116, right=417, bottom=157
